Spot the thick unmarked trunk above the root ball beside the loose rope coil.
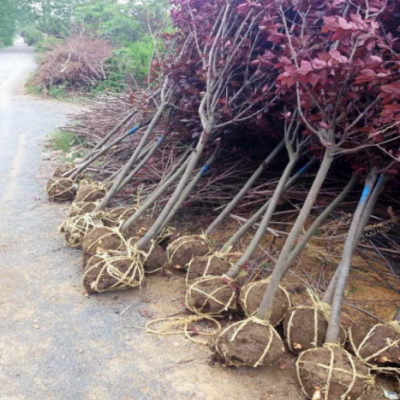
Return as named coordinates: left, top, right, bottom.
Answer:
left=257, top=149, right=334, bottom=321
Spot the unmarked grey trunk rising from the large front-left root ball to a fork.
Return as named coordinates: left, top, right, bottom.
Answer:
left=138, top=131, right=208, bottom=249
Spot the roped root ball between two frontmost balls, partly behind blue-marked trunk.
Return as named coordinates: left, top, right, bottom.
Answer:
left=283, top=303, right=347, bottom=354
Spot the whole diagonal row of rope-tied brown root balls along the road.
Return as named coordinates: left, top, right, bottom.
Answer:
left=47, top=166, right=400, bottom=400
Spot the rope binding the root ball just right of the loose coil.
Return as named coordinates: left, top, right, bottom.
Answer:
left=215, top=316, right=284, bottom=368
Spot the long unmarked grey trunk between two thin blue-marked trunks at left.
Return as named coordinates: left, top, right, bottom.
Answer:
left=96, top=102, right=167, bottom=211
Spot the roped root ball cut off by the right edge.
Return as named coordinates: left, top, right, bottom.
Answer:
left=349, top=321, right=400, bottom=374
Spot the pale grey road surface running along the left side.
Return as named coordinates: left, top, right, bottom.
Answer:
left=0, top=38, right=184, bottom=400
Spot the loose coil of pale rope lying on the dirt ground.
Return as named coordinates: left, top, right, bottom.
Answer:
left=145, top=315, right=221, bottom=345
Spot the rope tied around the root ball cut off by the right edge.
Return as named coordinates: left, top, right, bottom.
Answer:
left=349, top=321, right=400, bottom=374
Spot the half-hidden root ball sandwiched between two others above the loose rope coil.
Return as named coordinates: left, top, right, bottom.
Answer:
left=186, top=254, right=233, bottom=283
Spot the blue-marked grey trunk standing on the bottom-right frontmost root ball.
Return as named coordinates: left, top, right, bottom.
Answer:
left=325, top=173, right=376, bottom=343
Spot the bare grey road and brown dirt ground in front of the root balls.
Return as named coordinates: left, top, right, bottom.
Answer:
left=0, top=38, right=399, bottom=400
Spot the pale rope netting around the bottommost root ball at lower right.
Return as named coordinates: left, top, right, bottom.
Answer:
left=296, top=343, right=374, bottom=400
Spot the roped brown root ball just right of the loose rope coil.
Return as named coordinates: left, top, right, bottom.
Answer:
left=214, top=317, right=285, bottom=368
